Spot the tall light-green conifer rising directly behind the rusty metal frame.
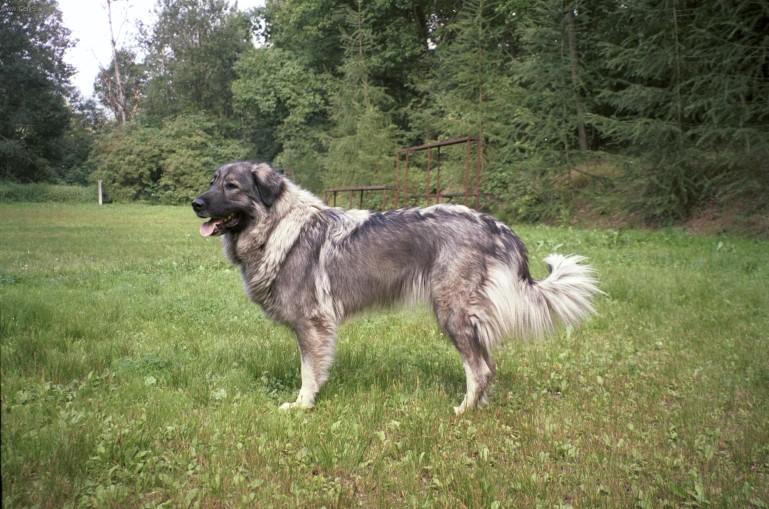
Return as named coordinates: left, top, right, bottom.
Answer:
left=426, top=0, right=530, bottom=205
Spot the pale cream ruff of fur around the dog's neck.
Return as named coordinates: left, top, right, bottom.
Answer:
left=223, top=181, right=328, bottom=304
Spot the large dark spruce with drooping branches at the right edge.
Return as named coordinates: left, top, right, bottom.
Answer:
left=591, top=0, right=769, bottom=221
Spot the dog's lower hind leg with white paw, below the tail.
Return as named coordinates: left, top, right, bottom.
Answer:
left=435, top=308, right=495, bottom=415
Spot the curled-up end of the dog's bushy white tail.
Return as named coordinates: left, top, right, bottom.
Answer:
left=530, top=254, right=601, bottom=335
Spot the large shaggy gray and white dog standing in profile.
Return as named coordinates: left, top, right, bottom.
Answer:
left=192, top=162, right=599, bottom=414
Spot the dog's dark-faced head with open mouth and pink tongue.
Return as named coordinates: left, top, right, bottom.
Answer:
left=192, top=161, right=285, bottom=237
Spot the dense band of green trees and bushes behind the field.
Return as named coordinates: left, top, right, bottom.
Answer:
left=0, top=0, right=769, bottom=222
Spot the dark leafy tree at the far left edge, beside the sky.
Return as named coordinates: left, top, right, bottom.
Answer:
left=0, top=0, right=73, bottom=181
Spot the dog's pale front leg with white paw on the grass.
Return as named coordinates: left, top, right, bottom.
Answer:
left=280, top=320, right=336, bottom=410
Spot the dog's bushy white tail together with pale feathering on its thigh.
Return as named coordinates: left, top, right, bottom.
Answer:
left=481, top=254, right=601, bottom=348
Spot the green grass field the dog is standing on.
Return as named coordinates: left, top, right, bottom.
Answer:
left=0, top=203, right=769, bottom=508
